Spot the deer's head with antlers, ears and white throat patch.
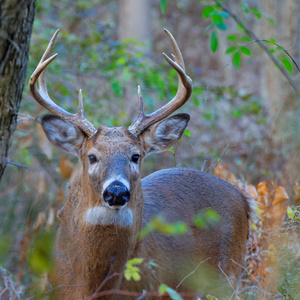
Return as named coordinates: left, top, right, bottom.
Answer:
left=29, top=29, right=192, bottom=226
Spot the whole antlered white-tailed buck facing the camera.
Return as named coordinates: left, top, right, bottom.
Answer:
left=29, top=30, right=250, bottom=300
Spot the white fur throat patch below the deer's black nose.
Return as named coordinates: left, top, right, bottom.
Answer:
left=85, top=206, right=133, bottom=227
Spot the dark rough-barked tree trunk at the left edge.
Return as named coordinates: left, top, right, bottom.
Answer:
left=0, top=0, right=36, bottom=180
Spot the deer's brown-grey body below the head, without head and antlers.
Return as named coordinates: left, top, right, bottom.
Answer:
left=55, top=164, right=249, bottom=299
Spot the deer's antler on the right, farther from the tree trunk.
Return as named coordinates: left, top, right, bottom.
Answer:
left=129, top=29, right=193, bottom=135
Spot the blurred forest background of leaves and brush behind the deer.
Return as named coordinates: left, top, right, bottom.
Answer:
left=0, top=0, right=300, bottom=299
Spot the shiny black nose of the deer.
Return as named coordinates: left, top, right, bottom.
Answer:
left=103, top=181, right=130, bottom=206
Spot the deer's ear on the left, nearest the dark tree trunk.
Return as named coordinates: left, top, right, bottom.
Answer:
left=42, top=115, right=85, bottom=154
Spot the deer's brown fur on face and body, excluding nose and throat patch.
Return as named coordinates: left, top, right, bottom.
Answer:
left=41, top=115, right=249, bottom=300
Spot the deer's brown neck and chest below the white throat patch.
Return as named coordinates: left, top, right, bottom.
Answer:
left=56, top=172, right=143, bottom=291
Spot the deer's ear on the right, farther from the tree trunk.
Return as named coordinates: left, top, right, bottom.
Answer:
left=140, top=114, right=190, bottom=154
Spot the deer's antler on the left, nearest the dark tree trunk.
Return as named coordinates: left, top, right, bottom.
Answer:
left=29, top=29, right=97, bottom=137
